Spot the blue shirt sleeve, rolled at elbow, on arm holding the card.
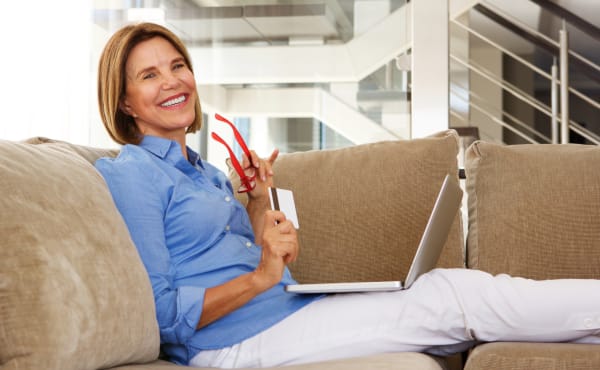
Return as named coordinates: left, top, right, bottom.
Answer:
left=96, top=159, right=205, bottom=343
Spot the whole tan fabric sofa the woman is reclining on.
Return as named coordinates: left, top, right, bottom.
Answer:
left=0, top=130, right=600, bottom=370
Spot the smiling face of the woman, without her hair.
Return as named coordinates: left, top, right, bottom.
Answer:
left=121, top=37, right=198, bottom=139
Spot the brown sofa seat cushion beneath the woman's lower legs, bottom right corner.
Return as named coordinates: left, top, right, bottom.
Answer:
left=465, top=342, right=600, bottom=370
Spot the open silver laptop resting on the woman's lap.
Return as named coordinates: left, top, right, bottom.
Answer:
left=285, top=175, right=462, bottom=294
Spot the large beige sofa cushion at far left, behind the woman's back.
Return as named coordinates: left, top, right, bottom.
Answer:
left=0, top=141, right=159, bottom=370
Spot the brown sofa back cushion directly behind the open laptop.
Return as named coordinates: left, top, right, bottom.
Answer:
left=253, top=131, right=463, bottom=282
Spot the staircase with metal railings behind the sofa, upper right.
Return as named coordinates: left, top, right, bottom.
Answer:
left=449, top=0, right=600, bottom=145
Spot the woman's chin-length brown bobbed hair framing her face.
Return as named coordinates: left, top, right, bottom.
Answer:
left=98, top=23, right=202, bottom=144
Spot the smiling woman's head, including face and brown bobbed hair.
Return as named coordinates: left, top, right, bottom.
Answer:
left=98, top=23, right=202, bottom=152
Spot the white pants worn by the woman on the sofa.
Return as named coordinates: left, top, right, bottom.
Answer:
left=190, top=269, right=600, bottom=368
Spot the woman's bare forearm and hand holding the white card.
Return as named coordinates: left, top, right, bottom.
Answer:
left=197, top=211, right=298, bottom=329
